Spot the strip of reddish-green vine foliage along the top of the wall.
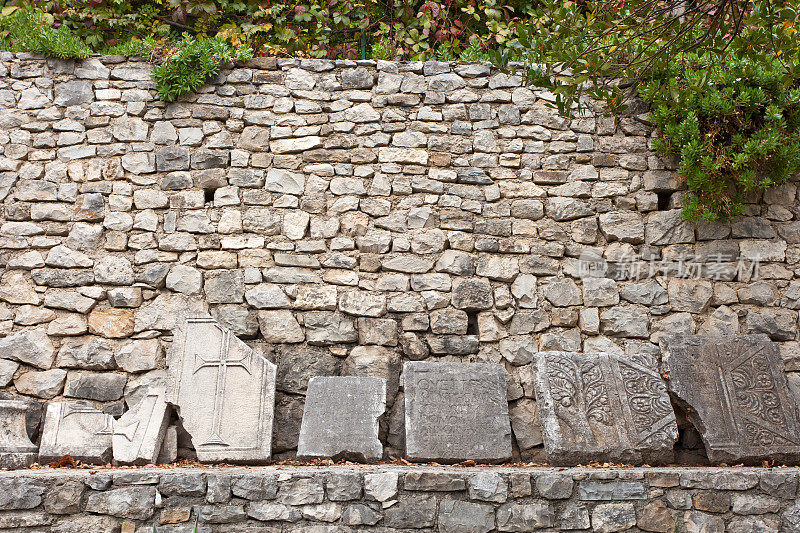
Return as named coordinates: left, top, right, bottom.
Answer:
left=7, top=0, right=538, bottom=60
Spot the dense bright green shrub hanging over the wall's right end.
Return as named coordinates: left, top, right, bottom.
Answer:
left=639, top=46, right=800, bottom=220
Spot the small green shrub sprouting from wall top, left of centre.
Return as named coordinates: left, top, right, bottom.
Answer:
left=153, top=34, right=253, bottom=102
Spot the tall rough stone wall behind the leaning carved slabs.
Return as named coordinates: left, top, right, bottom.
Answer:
left=0, top=53, right=800, bottom=458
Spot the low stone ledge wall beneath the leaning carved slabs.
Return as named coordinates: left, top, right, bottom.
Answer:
left=0, top=465, right=800, bottom=533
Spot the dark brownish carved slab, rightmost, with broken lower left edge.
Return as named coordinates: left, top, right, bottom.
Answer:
left=662, top=335, right=800, bottom=463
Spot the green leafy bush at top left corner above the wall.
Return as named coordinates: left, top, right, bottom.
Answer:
left=0, top=8, right=92, bottom=59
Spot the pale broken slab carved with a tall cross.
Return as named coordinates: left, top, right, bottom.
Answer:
left=167, top=317, right=275, bottom=463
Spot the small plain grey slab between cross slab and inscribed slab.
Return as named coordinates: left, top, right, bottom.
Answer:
left=297, top=377, right=386, bottom=461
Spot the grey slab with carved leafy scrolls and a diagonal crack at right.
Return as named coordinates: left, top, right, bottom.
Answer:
left=534, top=352, right=678, bottom=466
